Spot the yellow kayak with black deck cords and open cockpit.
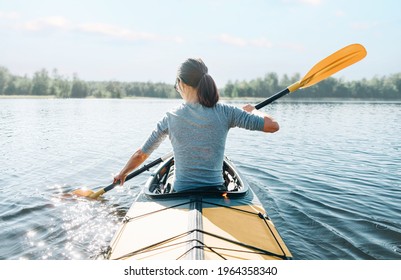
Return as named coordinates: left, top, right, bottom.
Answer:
left=104, top=157, right=292, bottom=260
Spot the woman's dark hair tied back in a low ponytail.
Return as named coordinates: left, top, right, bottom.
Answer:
left=177, top=58, right=219, bottom=107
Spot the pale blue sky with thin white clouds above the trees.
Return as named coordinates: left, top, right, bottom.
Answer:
left=0, top=0, right=401, bottom=87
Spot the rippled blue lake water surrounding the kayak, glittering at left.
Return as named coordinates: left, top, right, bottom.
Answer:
left=0, top=99, right=401, bottom=260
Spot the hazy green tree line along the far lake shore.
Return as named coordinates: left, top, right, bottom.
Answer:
left=0, top=67, right=401, bottom=100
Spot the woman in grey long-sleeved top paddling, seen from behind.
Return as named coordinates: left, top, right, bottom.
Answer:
left=114, top=58, right=279, bottom=192
